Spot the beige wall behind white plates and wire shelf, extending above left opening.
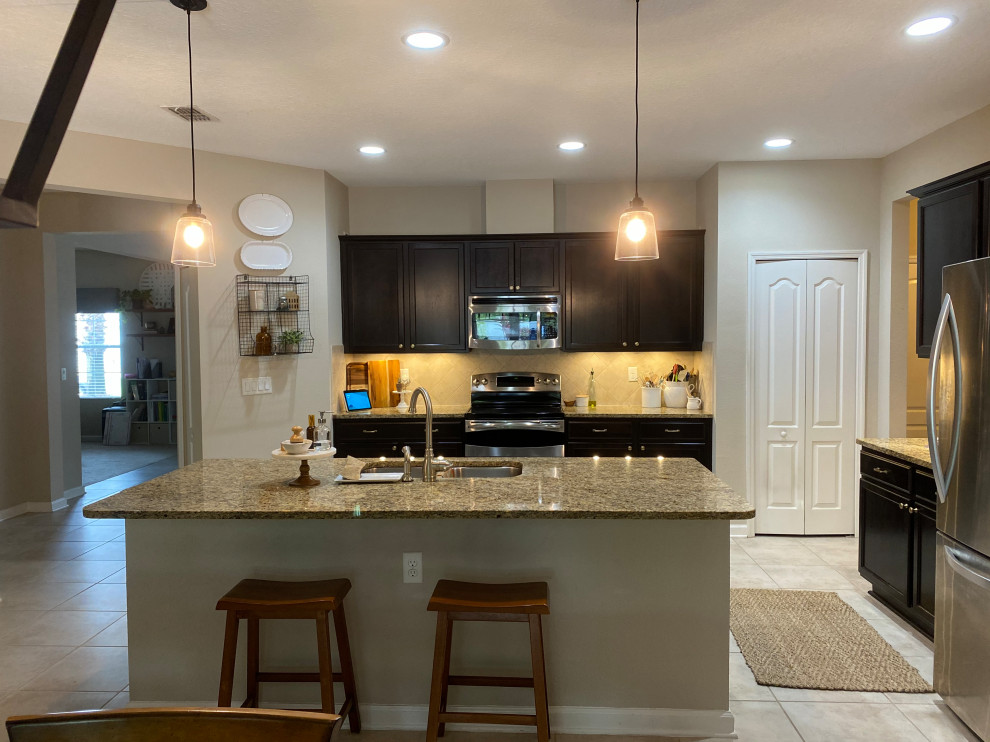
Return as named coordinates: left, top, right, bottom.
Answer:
left=0, top=122, right=348, bottom=480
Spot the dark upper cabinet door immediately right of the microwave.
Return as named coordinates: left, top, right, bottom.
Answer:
left=564, top=238, right=628, bottom=351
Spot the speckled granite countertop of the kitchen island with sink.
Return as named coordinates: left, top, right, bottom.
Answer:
left=83, top=458, right=755, bottom=520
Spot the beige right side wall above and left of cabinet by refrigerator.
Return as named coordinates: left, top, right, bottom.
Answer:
left=872, top=106, right=990, bottom=437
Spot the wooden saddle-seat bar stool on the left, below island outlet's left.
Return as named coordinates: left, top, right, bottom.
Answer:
left=217, top=579, right=361, bottom=733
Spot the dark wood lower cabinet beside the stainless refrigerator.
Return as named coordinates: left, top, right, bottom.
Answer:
left=859, top=451, right=936, bottom=636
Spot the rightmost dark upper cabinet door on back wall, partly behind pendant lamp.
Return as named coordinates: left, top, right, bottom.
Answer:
left=624, top=231, right=705, bottom=351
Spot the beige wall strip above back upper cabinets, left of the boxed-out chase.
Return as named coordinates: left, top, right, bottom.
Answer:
left=348, top=185, right=485, bottom=234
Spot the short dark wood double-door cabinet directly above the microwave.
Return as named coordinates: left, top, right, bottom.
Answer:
left=468, top=239, right=560, bottom=294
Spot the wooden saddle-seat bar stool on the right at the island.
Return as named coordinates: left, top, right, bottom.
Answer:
left=426, top=580, right=550, bottom=742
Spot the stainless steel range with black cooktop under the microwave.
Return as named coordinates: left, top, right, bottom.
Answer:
left=464, top=371, right=566, bottom=456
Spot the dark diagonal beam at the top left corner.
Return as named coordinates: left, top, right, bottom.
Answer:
left=0, top=0, right=116, bottom=228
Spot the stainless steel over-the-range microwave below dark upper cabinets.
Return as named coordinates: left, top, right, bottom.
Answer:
left=468, top=295, right=560, bottom=350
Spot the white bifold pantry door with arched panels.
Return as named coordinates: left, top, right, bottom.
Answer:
left=750, top=260, right=859, bottom=535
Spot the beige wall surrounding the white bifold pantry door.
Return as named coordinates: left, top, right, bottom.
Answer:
left=706, top=160, right=885, bottom=502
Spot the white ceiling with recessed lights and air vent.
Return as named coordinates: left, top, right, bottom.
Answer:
left=0, top=0, right=990, bottom=185
